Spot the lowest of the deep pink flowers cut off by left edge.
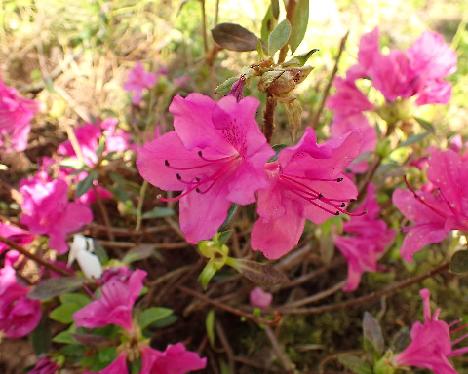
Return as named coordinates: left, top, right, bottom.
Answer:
left=0, top=266, right=41, bottom=338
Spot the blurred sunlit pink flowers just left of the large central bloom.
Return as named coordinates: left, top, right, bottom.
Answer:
left=58, top=118, right=131, bottom=167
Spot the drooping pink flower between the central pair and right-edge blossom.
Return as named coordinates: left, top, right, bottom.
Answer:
left=333, top=184, right=395, bottom=291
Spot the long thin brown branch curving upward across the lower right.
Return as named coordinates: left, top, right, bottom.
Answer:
left=284, top=262, right=449, bottom=315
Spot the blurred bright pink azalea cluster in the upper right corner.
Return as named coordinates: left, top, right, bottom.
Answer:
left=327, top=28, right=457, bottom=172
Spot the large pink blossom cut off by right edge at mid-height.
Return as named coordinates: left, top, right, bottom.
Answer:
left=393, top=150, right=468, bottom=261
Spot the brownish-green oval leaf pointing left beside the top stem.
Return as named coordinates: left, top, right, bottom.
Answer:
left=211, top=22, right=257, bottom=52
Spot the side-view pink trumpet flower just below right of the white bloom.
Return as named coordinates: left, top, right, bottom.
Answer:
left=73, top=270, right=146, bottom=331
